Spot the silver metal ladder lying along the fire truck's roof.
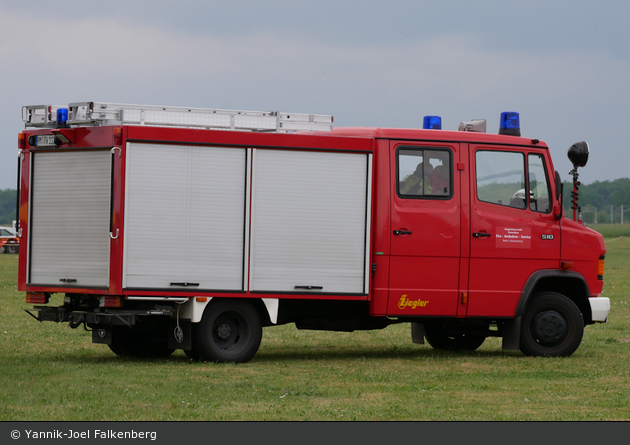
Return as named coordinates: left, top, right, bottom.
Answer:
left=22, top=102, right=333, bottom=132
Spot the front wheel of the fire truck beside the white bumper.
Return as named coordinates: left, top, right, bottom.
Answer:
left=520, top=292, right=584, bottom=357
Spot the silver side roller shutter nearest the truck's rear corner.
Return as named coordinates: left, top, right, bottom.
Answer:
left=123, top=143, right=247, bottom=291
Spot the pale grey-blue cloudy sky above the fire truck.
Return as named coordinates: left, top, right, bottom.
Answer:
left=0, top=0, right=630, bottom=189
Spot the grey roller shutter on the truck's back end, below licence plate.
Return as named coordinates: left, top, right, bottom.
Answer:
left=29, top=150, right=111, bottom=287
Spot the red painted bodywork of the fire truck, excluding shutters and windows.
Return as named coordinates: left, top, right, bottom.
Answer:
left=18, top=122, right=605, bottom=317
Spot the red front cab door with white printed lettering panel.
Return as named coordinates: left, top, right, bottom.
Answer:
left=467, top=144, right=560, bottom=317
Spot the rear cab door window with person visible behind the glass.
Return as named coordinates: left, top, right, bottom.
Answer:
left=397, top=147, right=452, bottom=198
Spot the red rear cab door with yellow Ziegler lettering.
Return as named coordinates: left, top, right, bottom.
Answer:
left=388, top=141, right=461, bottom=316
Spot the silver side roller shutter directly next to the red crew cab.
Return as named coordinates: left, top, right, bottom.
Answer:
left=250, top=149, right=370, bottom=294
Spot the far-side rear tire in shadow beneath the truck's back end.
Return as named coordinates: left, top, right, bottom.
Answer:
left=109, top=330, right=174, bottom=358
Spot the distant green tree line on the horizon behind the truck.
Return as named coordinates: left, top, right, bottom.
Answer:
left=0, top=178, right=630, bottom=225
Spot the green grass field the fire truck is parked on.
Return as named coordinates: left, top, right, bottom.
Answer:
left=0, top=238, right=630, bottom=421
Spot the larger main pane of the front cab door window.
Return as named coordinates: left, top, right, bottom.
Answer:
left=475, top=151, right=527, bottom=209
